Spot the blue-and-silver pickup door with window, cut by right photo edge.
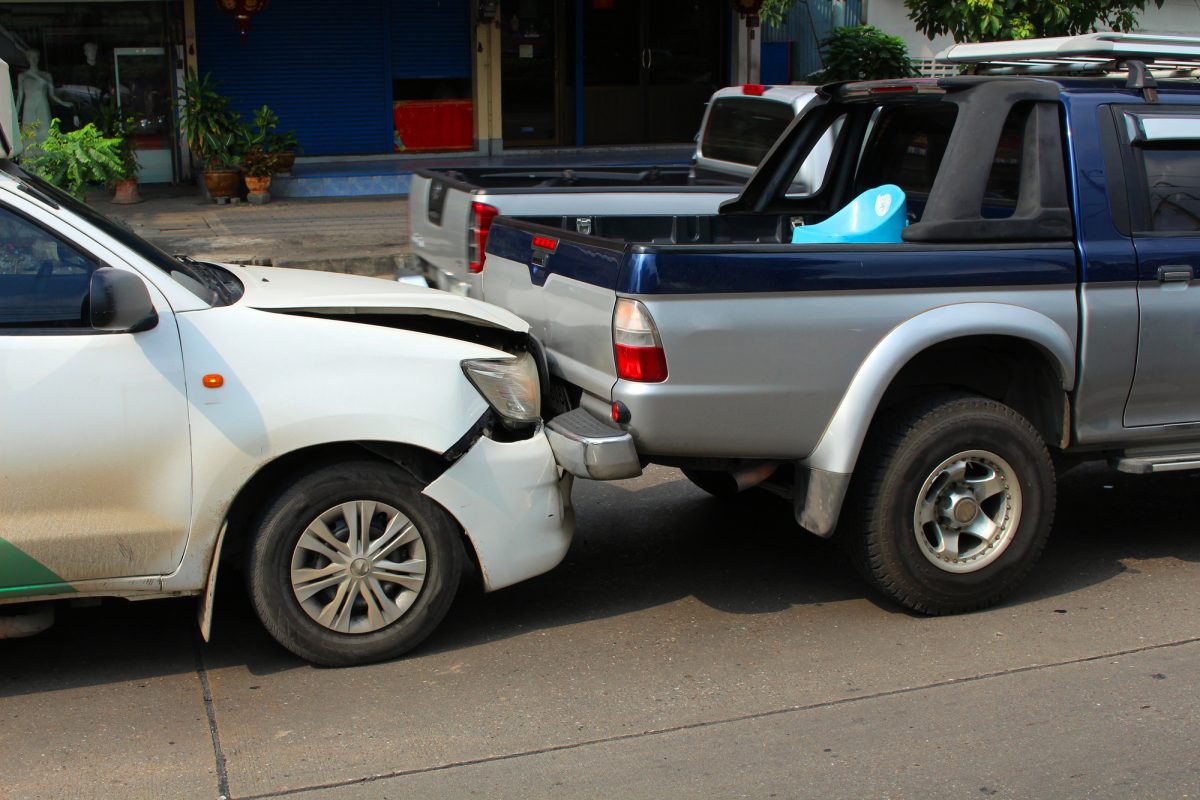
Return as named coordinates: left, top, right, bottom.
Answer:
left=1123, top=107, right=1200, bottom=427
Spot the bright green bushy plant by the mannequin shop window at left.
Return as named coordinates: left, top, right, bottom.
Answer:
left=20, top=119, right=125, bottom=200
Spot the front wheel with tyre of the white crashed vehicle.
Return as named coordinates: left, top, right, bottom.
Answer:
left=247, top=461, right=462, bottom=667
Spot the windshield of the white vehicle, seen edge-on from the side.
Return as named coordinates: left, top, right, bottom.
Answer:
left=0, top=160, right=242, bottom=306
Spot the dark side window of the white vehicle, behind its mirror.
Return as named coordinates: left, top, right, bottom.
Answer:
left=0, top=207, right=98, bottom=330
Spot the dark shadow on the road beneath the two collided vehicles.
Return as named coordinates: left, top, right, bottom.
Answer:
left=0, top=465, right=1200, bottom=697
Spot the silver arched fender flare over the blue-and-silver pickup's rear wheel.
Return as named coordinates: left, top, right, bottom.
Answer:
left=800, top=302, right=1075, bottom=474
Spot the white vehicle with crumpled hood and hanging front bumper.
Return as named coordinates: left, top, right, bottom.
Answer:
left=0, top=68, right=574, bottom=664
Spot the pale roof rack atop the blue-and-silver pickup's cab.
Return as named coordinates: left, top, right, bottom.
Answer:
left=937, top=31, right=1200, bottom=102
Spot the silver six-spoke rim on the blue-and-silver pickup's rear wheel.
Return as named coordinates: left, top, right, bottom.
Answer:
left=913, top=450, right=1021, bottom=572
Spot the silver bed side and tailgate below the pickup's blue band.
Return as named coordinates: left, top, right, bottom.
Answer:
left=487, top=250, right=1078, bottom=462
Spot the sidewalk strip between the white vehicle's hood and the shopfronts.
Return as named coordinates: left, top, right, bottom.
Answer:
left=99, top=186, right=408, bottom=277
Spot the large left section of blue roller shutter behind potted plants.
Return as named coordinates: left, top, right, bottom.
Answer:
left=196, top=0, right=388, bottom=156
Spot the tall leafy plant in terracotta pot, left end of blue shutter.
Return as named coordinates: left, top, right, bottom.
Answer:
left=179, top=71, right=246, bottom=198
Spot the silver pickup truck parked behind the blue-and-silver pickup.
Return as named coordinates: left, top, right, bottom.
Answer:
left=408, top=85, right=828, bottom=297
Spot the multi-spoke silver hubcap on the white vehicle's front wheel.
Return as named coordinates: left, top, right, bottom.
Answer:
left=290, top=500, right=425, bottom=633
